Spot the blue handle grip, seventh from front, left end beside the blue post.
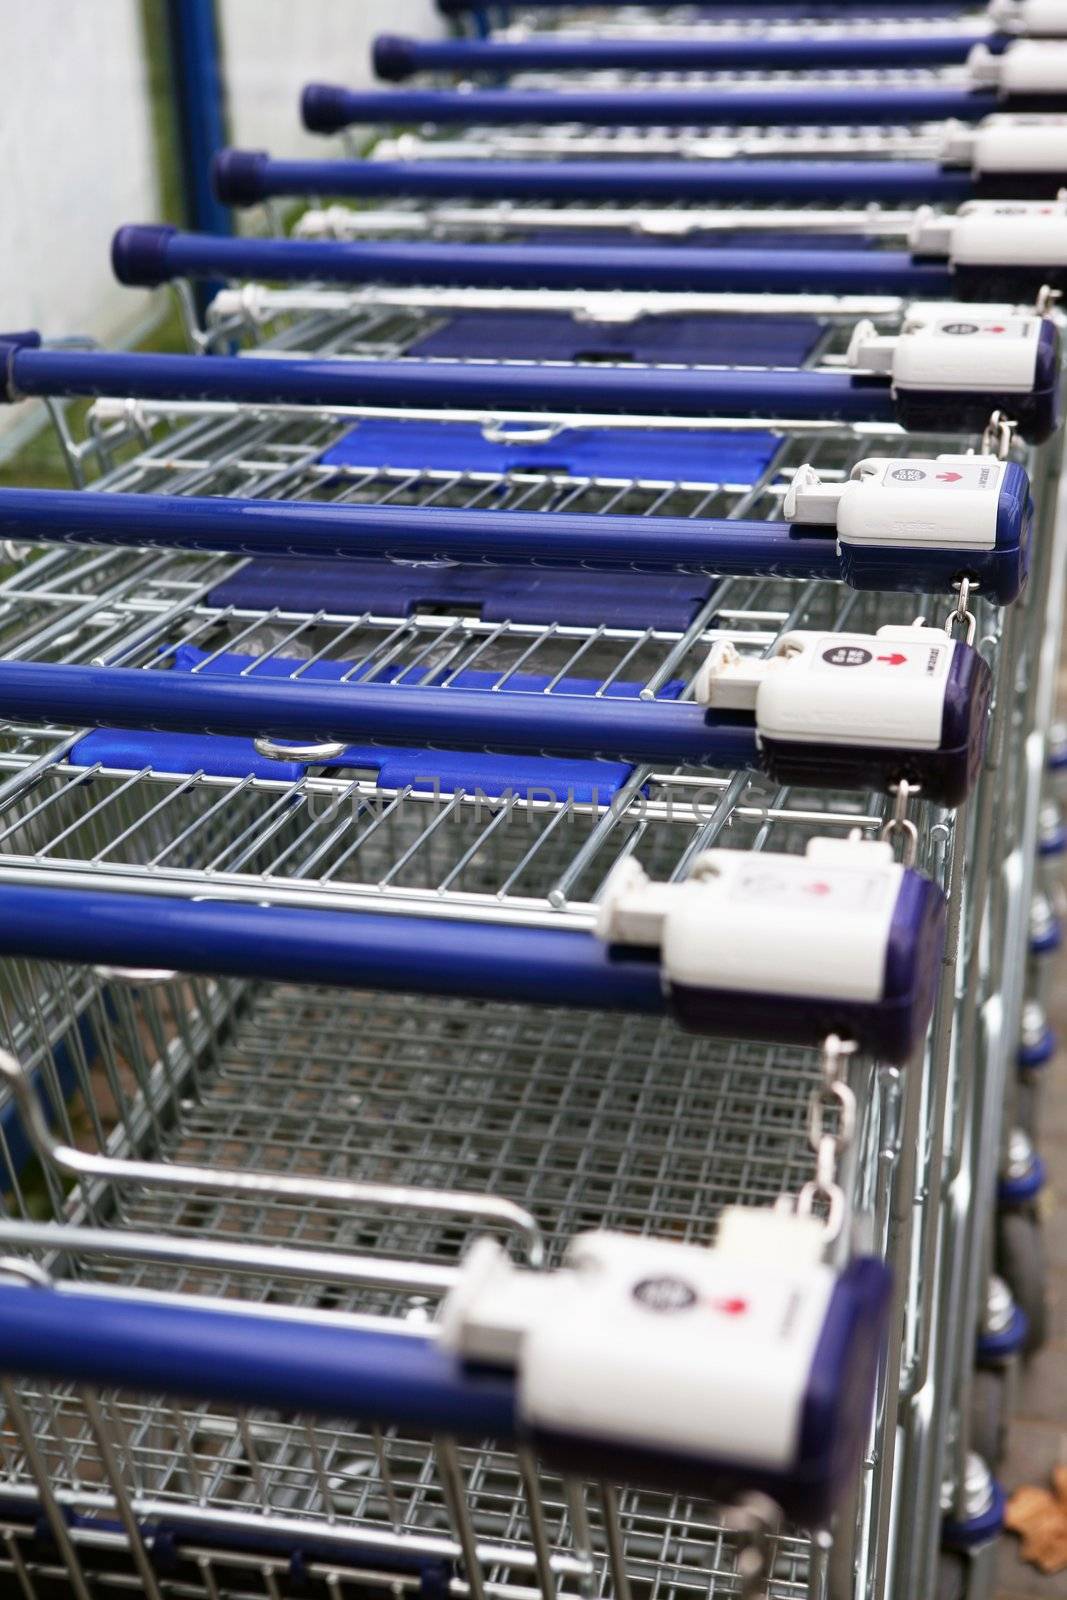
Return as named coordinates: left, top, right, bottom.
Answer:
left=213, top=150, right=976, bottom=205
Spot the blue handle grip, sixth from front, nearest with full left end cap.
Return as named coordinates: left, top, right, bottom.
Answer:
left=112, top=224, right=952, bottom=309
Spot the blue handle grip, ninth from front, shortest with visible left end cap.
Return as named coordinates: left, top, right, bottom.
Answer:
left=373, top=32, right=991, bottom=83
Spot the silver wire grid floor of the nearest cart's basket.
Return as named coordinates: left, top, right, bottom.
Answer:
left=0, top=986, right=885, bottom=1600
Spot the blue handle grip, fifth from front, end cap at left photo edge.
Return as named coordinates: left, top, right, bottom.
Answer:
left=0, top=337, right=921, bottom=421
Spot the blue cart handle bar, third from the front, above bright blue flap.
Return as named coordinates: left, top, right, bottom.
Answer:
left=0, top=661, right=758, bottom=768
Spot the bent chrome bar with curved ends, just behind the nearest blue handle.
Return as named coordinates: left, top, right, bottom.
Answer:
left=0, top=1050, right=544, bottom=1264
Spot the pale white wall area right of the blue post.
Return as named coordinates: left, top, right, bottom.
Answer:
left=218, top=0, right=443, bottom=158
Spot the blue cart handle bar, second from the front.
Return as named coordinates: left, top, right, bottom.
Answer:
left=0, top=874, right=667, bottom=1016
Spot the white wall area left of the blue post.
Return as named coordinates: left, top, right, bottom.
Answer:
left=0, top=0, right=158, bottom=341
